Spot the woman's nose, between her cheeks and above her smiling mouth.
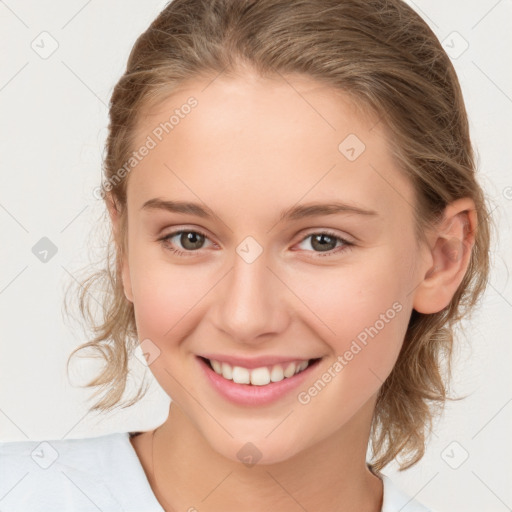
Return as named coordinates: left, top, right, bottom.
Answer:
left=214, top=252, right=290, bottom=344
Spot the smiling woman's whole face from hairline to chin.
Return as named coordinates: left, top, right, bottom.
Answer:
left=114, top=71, right=428, bottom=463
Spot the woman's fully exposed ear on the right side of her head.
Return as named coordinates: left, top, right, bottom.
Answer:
left=413, top=197, right=477, bottom=314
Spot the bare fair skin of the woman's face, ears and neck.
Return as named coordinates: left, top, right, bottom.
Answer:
left=109, top=73, right=476, bottom=512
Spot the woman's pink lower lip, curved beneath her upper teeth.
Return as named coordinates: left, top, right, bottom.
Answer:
left=197, top=357, right=320, bottom=406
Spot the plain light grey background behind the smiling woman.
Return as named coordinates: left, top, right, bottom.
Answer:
left=0, top=0, right=512, bottom=512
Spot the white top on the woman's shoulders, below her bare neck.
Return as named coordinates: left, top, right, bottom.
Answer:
left=0, top=432, right=433, bottom=512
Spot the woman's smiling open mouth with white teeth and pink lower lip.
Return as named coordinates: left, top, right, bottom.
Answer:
left=196, top=356, right=322, bottom=406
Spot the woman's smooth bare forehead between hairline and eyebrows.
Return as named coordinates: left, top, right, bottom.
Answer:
left=128, top=75, right=412, bottom=222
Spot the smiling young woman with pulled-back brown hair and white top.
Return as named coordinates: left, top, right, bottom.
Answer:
left=0, top=0, right=489, bottom=512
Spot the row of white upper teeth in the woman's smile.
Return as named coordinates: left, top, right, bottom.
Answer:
left=209, top=359, right=309, bottom=386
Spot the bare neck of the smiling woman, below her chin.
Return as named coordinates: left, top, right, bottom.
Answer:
left=143, top=402, right=382, bottom=512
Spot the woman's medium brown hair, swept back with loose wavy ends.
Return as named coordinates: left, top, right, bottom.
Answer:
left=64, top=0, right=491, bottom=469
